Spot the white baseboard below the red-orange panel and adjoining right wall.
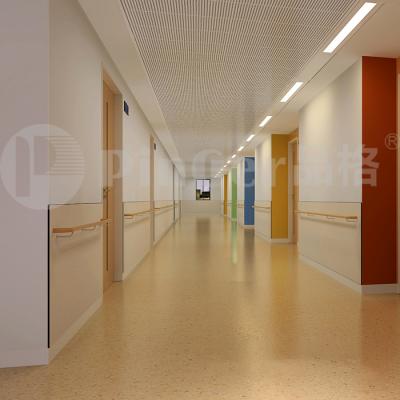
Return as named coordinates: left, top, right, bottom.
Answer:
left=299, top=255, right=400, bottom=294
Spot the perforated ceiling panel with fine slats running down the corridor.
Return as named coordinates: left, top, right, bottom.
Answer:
left=121, top=0, right=357, bottom=161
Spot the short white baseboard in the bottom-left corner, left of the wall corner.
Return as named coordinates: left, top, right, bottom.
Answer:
left=0, top=348, right=49, bottom=369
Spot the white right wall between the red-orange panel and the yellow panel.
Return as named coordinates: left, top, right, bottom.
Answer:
left=299, top=61, right=362, bottom=285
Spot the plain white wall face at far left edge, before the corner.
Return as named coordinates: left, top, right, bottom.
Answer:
left=0, top=0, right=49, bottom=367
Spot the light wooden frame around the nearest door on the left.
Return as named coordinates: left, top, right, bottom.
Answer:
left=101, top=67, right=124, bottom=288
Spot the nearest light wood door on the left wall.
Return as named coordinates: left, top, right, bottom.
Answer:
left=103, top=82, right=115, bottom=291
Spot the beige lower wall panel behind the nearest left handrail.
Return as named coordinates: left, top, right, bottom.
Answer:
left=50, top=204, right=103, bottom=350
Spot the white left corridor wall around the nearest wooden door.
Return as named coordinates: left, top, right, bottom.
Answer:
left=50, top=0, right=161, bottom=362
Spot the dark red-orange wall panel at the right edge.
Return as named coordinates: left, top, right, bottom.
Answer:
left=362, top=57, right=397, bottom=285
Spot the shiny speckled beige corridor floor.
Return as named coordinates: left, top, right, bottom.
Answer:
left=0, top=217, right=400, bottom=400
